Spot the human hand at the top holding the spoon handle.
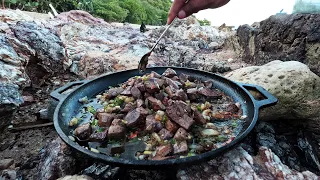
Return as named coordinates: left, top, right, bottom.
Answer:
left=167, top=0, right=230, bottom=24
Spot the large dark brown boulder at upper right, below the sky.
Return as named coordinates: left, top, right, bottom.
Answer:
left=237, top=13, right=320, bottom=75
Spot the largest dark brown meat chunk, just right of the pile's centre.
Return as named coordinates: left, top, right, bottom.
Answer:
left=166, top=104, right=194, bottom=130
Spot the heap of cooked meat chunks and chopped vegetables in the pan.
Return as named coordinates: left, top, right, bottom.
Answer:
left=69, top=68, right=245, bottom=160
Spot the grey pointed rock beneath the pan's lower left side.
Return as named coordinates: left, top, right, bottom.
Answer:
left=37, top=138, right=76, bottom=179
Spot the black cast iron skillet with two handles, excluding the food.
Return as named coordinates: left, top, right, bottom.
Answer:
left=51, top=67, right=278, bottom=169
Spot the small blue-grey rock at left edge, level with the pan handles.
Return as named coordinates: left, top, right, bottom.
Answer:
left=0, top=82, right=23, bottom=131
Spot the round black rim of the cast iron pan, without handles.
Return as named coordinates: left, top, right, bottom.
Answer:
left=53, top=66, right=259, bottom=168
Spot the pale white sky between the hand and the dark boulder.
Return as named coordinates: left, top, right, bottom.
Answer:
left=194, top=0, right=295, bottom=27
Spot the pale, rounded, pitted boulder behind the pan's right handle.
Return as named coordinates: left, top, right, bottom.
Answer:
left=226, top=60, right=320, bottom=120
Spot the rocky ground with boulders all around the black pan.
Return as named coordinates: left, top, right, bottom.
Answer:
left=0, top=10, right=320, bottom=179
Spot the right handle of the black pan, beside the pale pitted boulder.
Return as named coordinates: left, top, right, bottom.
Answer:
left=238, top=82, right=278, bottom=108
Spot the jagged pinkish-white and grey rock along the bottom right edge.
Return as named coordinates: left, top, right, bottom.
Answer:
left=177, top=147, right=319, bottom=180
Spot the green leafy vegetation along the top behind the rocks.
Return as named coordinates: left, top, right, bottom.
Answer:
left=5, top=0, right=171, bottom=25
